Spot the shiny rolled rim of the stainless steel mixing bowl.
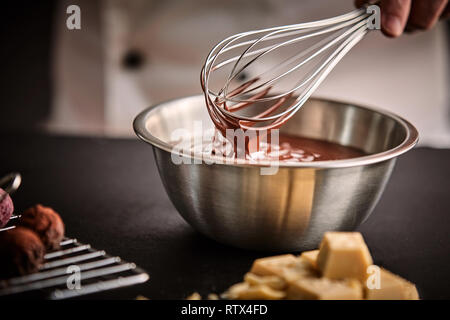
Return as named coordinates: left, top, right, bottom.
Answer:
left=133, top=95, right=419, bottom=168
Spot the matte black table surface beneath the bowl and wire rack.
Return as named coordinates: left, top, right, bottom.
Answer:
left=0, top=133, right=450, bottom=299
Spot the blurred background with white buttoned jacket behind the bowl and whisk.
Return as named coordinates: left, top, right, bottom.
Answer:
left=0, top=0, right=450, bottom=147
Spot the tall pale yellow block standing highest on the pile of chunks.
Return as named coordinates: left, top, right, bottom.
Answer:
left=317, top=232, right=372, bottom=281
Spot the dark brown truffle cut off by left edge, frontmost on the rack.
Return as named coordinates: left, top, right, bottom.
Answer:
left=0, top=227, right=45, bottom=279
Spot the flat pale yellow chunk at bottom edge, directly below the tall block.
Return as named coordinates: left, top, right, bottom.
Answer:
left=286, top=277, right=363, bottom=300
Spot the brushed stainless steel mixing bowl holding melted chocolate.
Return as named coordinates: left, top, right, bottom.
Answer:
left=134, top=96, right=418, bottom=251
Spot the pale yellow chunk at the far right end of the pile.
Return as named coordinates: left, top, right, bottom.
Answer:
left=364, top=268, right=419, bottom=300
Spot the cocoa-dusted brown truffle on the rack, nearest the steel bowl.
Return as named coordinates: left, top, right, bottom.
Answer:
left=17, top=204, right=64, bottom=250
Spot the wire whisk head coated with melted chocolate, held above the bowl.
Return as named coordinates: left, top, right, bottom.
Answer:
left=201, top=9, right=371, bottom=133
